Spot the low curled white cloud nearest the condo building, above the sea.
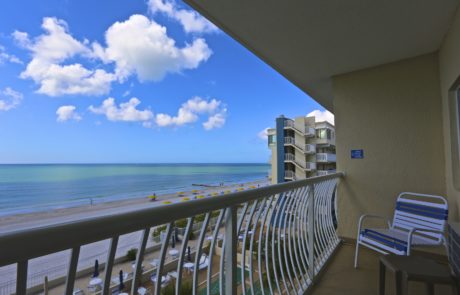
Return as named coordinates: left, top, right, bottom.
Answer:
left=155, top=96, right=227, bottom=130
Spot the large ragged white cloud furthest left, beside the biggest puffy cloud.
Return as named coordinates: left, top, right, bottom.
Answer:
left=13, top=17, right=115, bottom=96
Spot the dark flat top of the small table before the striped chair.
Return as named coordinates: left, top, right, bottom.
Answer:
left=380, top=255, right=451, bottom=278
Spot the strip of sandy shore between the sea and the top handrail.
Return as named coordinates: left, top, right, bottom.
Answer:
left=0, top=178, right=269, bottom=233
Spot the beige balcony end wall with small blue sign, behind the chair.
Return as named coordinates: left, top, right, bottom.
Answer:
left=333, top=51, right=448, bottom=238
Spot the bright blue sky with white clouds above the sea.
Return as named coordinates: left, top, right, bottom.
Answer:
left=0, top=0, right=323, bottom=163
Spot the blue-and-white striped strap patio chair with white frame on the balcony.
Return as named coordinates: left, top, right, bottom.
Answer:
left=354, top=192, right=448, bottom=268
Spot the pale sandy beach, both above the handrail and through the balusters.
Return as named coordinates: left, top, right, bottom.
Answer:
left=0, top=179, right=268, bottom=291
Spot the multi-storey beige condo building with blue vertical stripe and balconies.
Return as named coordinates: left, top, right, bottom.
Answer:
left=268, top=115, right=336, bottom=183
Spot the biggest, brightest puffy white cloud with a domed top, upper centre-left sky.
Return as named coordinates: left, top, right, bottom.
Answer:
left=98, top=15, right=212, bottom=81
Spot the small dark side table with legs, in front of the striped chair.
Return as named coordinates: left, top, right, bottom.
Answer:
left=379, top=255, right=458, bottom=295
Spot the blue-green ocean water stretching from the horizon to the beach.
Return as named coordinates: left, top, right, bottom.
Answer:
left=0, top=164, right=270, bottom=215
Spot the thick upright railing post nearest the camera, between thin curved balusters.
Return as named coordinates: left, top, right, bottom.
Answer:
left=225, top=206, right=238, bottom=295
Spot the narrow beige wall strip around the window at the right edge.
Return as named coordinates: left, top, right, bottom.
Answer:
left=439, top=5, right=460, bottom=220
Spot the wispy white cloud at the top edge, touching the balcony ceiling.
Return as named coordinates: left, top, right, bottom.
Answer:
left=148, top=0, right=218, bottom=33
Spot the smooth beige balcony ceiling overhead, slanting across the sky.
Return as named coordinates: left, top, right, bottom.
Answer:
left=185, top=0, right=459, bottom=110
